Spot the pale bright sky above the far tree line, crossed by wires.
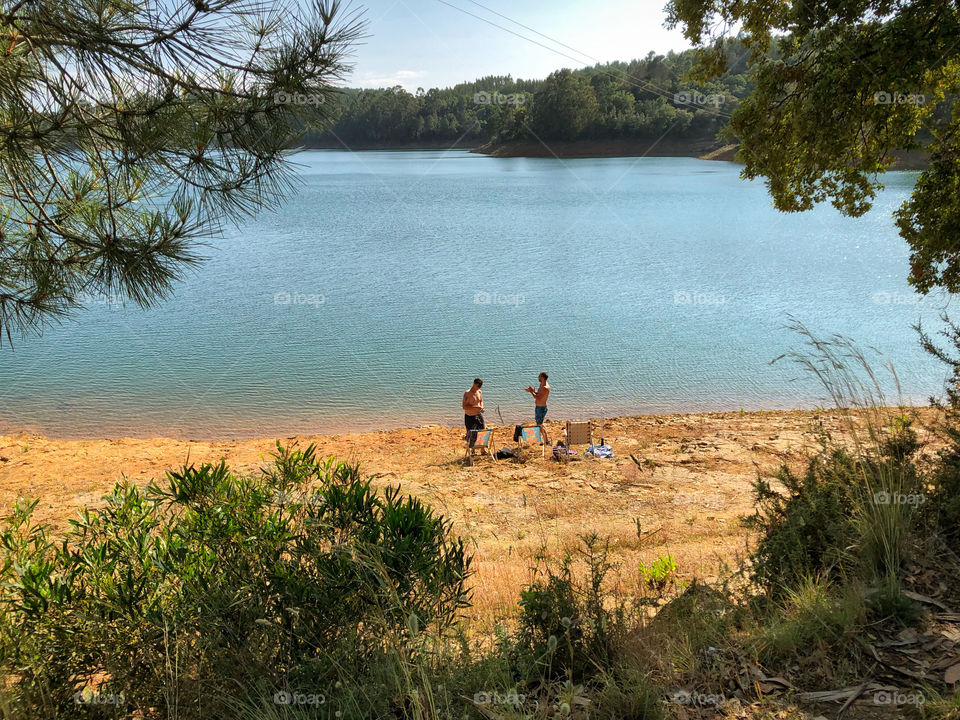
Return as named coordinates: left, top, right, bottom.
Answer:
left=346, top=0, right=690, bottom=92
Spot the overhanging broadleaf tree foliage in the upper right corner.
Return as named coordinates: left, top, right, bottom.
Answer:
left=667, top=0, right=960, bottom=292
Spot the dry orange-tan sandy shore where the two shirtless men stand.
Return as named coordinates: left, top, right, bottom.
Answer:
left=0, top=409, right=933, bottom=622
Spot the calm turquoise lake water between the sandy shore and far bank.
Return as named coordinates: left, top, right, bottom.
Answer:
left=0, top=151, right=945, bottom=437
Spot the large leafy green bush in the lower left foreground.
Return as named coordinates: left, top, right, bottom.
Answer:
left=0, top=443, right=470, bottom=718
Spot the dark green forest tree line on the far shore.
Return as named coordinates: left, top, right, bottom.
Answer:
left=301, top=41, right=751, bottom=147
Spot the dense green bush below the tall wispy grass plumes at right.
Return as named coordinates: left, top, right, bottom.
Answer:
left=745, top=416, right=925, bottom=596
